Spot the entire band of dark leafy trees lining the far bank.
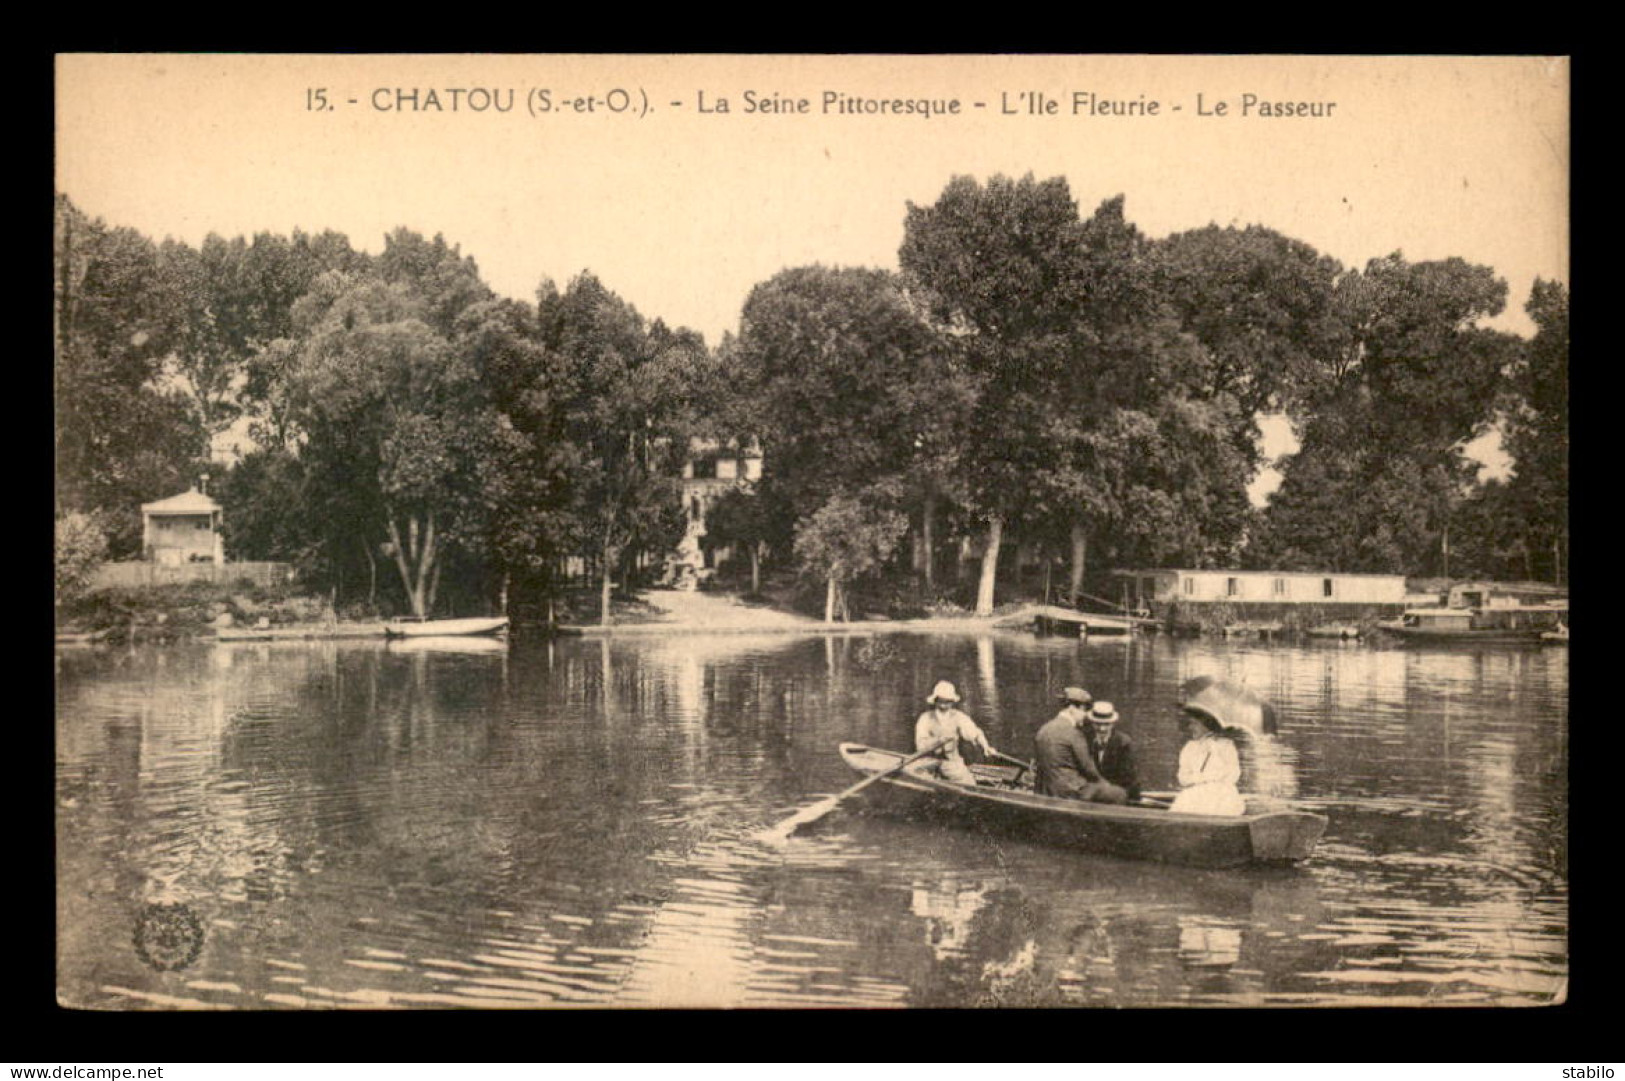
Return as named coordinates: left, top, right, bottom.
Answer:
left=55, top=176, right=1568, bottom=618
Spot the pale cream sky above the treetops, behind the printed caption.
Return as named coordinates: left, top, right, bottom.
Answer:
left=57, top=54, right=1570, bottom=494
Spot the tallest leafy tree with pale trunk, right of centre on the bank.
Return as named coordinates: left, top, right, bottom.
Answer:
left=902, top=185, right=1254, bottom=611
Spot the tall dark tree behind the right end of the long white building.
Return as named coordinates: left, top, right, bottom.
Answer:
left=1253, top=254, right=1518, bottom=574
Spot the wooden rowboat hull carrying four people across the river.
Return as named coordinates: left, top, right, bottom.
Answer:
left=840, top=743, right=1326, bottom=866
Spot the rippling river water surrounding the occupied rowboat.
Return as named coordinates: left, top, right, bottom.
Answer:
left=55, top=634, right=1568, bottom=1009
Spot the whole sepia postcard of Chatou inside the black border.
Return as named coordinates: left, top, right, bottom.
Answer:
left=52, top=54, right=1571, bottom=1007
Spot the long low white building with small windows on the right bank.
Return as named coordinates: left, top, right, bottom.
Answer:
left=1116, top=569, right=1406, bottom=608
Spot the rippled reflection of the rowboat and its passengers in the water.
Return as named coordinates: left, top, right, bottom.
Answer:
left=764, top=816, right=1326, bottom=1006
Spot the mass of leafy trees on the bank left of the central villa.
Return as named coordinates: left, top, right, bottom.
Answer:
left=55, top=198, right=712, bottom=614
